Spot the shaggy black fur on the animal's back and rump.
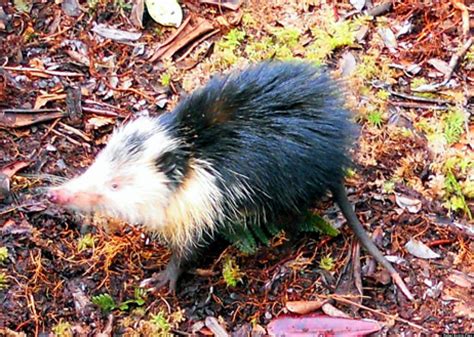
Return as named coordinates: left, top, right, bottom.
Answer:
left=160, top=62, right=356, bottom=227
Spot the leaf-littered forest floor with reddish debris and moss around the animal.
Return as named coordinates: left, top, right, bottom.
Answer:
left=0, top=0, right=474, bottom=336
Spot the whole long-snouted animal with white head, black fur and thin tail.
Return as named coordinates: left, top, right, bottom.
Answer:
left=46, top=62, right=412, bottom=298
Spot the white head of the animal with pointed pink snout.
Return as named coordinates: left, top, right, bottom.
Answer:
left=48, top=117, right=182, bottom=224
